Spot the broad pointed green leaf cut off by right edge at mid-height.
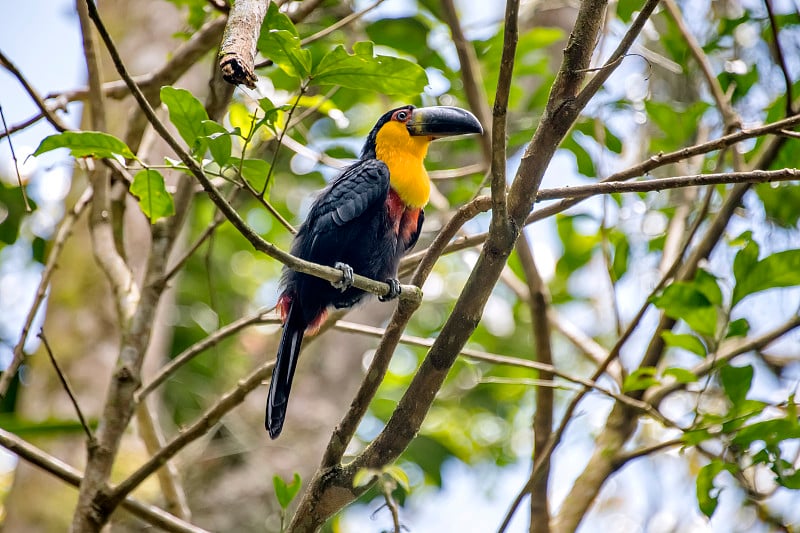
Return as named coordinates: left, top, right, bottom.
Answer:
left=732, top=245, right=800, bottom=305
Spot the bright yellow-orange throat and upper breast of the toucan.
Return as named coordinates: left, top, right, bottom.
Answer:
left=375, top=120, right=431, bottom=208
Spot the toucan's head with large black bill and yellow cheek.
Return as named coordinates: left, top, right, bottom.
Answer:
left=361, top=105, right=483, bottom=159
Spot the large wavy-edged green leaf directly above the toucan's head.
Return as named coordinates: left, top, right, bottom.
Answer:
left=312, top=41, right=428, bottom=95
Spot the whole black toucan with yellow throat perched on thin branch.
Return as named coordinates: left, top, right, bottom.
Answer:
left=265, top=105, right=483, bottom=439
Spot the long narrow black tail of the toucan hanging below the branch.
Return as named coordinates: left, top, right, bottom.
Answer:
left=264, top=300, right=306, bottom=439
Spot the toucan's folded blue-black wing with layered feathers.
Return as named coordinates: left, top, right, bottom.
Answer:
left=308, top=159, right=389, bottom=234
